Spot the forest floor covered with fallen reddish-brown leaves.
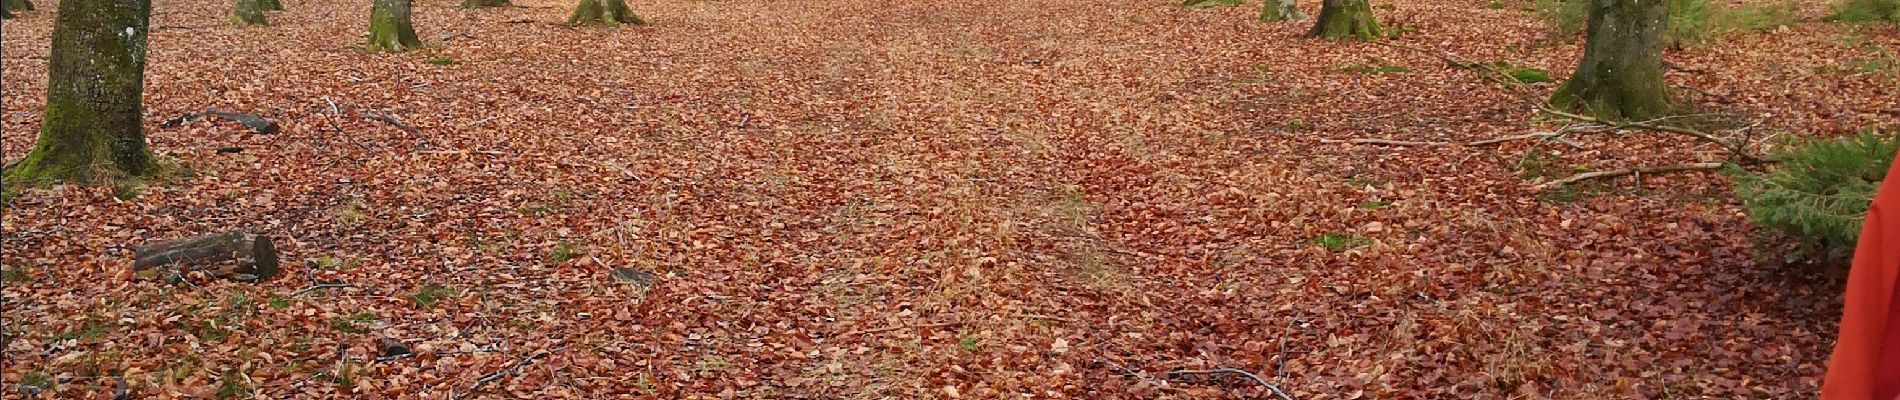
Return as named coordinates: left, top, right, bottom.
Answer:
left=0, top=0, right=1900, bottom=400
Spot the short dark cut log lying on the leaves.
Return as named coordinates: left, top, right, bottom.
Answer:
left=131, top=231, right=277, bottom=281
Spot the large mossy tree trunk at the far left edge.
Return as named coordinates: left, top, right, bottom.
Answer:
left=4, top=0, right=158, bottom=184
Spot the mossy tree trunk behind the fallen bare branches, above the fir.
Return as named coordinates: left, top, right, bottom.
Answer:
left=1550, top=0, right=1668, bottom=119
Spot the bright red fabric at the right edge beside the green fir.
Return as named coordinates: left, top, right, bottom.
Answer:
left=1820, top=152, right=1900, bottom=400
